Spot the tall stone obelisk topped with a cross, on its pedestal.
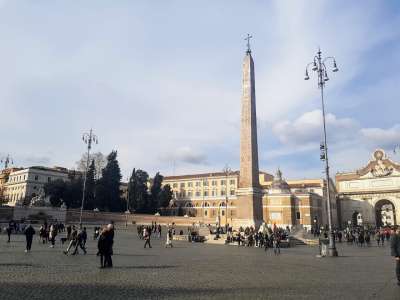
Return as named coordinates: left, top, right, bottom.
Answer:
left=235, top=35, right=263, bottom=227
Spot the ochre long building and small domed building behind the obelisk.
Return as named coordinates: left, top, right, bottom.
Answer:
left=163, top=170, right=338, bottom=229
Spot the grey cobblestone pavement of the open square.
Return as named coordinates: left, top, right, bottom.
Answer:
left=0, top=228, right=400, bottom=300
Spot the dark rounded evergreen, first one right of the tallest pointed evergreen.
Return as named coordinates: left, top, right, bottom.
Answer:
left=129, top=169, right=149, bottom=213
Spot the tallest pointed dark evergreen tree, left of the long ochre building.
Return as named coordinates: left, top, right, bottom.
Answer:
left=95, top=151, right=124, bottom=211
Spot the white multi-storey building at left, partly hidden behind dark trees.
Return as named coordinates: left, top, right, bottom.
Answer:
left=4, top=166, right=70, bottom=206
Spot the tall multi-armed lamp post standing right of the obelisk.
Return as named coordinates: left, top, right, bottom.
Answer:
left=304, top=49, right=339, bottom=256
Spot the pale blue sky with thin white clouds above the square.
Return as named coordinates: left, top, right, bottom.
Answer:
left=0, top=0, right=400, bottom=179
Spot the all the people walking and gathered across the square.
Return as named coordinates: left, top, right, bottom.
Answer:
left=0, top=221, right=400, bottom=285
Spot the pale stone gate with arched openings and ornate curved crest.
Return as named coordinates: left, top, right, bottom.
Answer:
left=336, top=149, right=400, bottom=227
